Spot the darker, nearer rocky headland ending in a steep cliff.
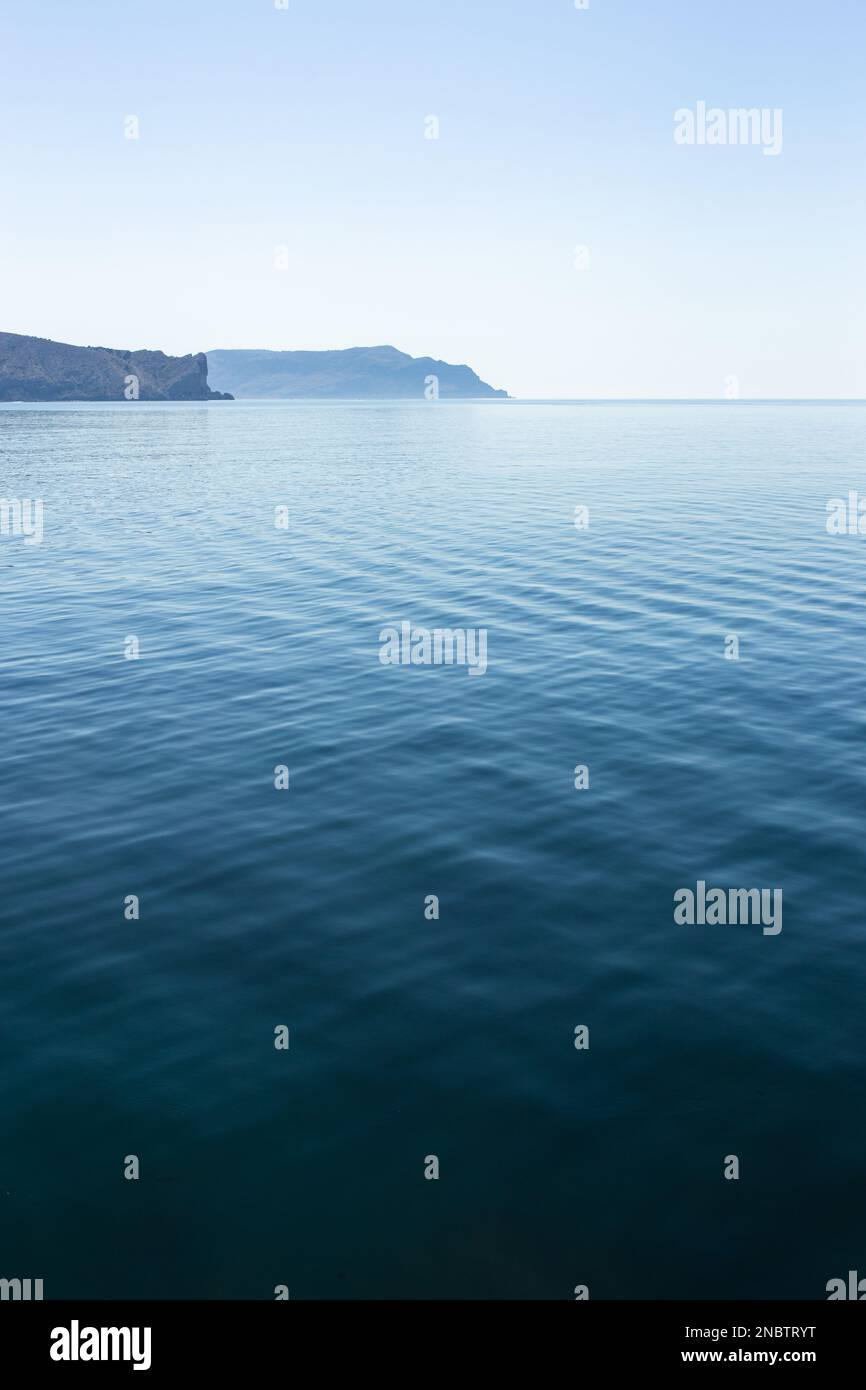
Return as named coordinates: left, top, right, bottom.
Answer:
left=0, top=332, right=231, bottom=400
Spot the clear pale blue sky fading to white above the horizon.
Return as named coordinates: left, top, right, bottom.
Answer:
left=0, top=0, right=866, bottom=399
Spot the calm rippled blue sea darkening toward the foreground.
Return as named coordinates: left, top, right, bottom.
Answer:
left=0, top=402, right=866, bottom=1300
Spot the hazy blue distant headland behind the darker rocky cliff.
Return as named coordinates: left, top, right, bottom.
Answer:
left=207, top=346, right=507, bottom=400
